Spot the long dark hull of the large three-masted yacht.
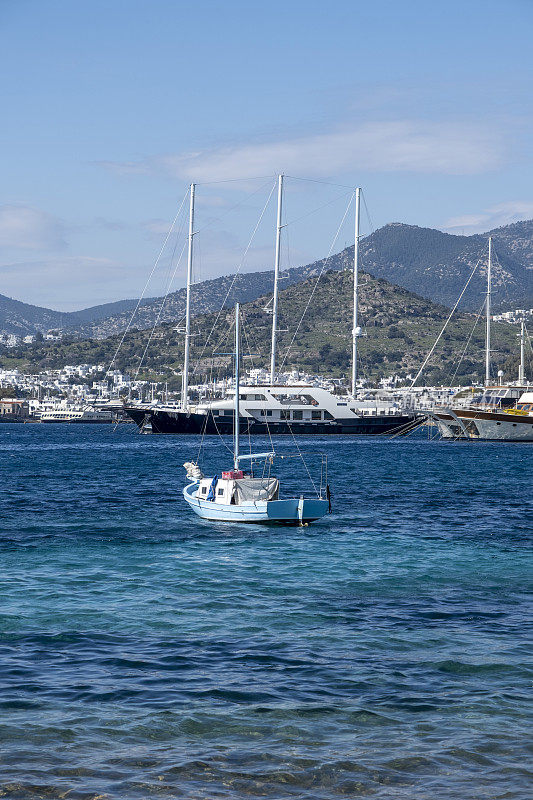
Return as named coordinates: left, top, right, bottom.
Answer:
left=126, top=408, right=415, bottom=436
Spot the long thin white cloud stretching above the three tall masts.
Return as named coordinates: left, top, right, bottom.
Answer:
left=102, top=120, right=502, bottom=182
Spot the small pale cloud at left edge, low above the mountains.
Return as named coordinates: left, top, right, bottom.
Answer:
left=0, top=205, right=66, bottom=250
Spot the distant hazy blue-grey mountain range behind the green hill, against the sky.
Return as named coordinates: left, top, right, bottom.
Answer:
left=0, top=220, right=533, bottom=338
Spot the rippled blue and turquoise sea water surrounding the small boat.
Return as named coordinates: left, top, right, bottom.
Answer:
left=0, top=424, right=533, bottom=800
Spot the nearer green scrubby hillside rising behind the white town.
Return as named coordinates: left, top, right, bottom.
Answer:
left=0, top=270, right=517, bottom=388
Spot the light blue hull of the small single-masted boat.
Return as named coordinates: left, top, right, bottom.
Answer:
left=183, top=483, right=329, bottom=525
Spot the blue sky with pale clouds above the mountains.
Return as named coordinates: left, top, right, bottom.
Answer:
left=0, top=0, right=533, bottom=310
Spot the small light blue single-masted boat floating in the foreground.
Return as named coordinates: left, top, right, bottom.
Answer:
left=183, top=303, right=331, bottom=525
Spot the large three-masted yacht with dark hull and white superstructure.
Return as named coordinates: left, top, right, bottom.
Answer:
left=124, top=175, right=416, bottom=435
